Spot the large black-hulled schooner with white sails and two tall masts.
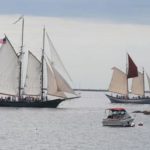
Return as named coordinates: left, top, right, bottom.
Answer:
left=0, top=18, right=78, bottom=108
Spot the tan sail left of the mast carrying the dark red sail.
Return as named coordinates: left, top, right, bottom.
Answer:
left=109, top=67, right=127, bottom=95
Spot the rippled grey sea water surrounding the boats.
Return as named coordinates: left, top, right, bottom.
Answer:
left=0, top=92, right=150, bottom=150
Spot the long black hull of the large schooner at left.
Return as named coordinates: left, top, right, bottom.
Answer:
left=0, top=99, right=64, bottom=108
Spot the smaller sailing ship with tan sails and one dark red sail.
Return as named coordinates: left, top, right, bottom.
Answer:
left=106, top=54, right=150, bottom=104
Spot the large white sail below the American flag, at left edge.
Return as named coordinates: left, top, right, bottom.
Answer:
left=0, top=37, right=19, bottom=95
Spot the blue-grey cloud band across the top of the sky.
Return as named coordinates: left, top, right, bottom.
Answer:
left=0, top=0, right=150, bottom=24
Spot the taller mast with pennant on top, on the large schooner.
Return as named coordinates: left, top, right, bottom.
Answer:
left=17, top=17, right=24, bottom=100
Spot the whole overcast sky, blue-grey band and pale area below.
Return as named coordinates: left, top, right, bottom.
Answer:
left=0, top=0, right=150, bottom=89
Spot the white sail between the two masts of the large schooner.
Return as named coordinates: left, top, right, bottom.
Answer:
left=24, top=52, right=41, bottom=95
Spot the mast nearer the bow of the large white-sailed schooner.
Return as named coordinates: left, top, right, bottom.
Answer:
left=41, top=27, right=45, bottom=101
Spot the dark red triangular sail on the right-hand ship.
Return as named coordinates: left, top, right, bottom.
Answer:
left=127, top=54, right=138, bottom=78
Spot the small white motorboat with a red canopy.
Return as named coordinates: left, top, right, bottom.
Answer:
left=102, top=108, right=134, bottom=127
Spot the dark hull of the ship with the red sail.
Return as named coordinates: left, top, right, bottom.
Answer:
left=106, top=94, right=150, bottom=104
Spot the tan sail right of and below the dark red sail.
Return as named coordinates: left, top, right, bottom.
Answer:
left=131, top=72, right=144, bottom=96
